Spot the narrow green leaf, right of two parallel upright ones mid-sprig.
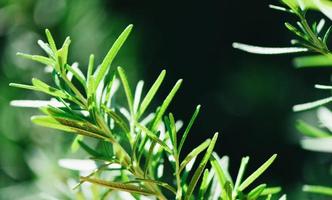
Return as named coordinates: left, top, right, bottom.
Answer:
left=151, top=79, right=182, bottom=130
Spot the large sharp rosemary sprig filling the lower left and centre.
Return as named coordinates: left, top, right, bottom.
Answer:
left=10, top=25, right=286, bottom=200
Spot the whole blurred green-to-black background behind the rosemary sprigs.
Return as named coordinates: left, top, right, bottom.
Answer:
left=0, top=0, right=332, bottom=199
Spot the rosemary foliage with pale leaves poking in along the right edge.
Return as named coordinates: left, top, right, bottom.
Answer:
left=233, top=0, right=332, bottom=197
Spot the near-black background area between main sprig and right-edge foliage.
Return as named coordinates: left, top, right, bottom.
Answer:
left=0, top=0, right=331, bottom=199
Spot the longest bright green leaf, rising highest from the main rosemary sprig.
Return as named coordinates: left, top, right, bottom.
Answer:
left=95, top=24, right=133, bottom=88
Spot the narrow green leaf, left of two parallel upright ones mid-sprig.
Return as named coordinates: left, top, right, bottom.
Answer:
left=137, top=70, right=166, bottom=118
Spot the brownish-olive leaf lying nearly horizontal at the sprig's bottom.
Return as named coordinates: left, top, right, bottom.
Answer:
left=81, top=177, right=156, bottom=196
